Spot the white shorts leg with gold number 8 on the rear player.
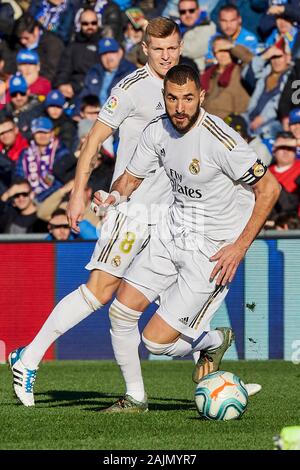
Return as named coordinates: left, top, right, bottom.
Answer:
left=86, top=208, right=150, bottom=278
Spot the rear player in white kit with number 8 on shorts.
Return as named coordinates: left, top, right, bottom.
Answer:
left=9, top=17, right=182, bottom=406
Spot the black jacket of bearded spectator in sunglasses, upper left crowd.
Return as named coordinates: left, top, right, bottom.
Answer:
left=54, top=32, right=100, bottom=94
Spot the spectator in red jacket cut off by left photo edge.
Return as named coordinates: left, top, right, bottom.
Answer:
left=0, top=115, right=28, bottom=162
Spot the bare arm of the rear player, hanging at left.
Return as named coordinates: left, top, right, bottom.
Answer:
left=67, top=121, right=113, bottom=232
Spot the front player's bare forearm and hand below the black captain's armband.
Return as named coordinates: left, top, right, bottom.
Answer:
left=211, top=171, right=281, bottom=286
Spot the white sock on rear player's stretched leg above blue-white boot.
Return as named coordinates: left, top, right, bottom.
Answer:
left=22, top=284, right=102, bottom=369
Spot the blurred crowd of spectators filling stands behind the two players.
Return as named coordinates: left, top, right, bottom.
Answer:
left=0, top=0, right=300, bottom=240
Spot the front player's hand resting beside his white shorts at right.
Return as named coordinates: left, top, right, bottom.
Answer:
left=210, top=243, right=247, bottom=286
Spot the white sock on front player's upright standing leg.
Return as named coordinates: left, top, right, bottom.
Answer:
left=109, top=299, right=145, bottom=401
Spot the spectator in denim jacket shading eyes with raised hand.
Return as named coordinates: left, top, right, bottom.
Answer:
left=243, top=46, right=290, bottom=139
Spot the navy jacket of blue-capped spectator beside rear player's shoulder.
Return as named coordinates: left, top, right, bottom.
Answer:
left=79, top=59, right=136, bottom=107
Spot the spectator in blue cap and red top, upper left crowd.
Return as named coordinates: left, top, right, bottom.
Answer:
left=17, top=49, right=52, bottom=99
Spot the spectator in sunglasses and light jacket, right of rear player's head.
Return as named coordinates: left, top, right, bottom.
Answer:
left=178, top=0, right=216, bottom=72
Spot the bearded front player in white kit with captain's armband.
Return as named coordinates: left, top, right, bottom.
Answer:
left=98, top=65, right=280, bottom=412
